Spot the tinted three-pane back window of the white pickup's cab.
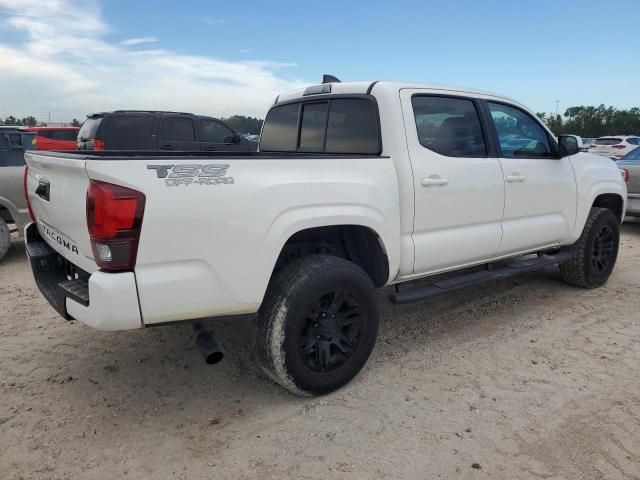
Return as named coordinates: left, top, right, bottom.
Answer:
left=260, top=95, right=382, bottom=155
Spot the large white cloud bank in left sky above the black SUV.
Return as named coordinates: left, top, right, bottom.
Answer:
left=0, top=0, right=308, bottom=121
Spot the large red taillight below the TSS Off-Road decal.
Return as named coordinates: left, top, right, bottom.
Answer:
left=87, top=180, right=146, bottom=270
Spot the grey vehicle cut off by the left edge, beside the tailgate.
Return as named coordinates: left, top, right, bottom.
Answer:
left=0, top=127, right=36, bottom=260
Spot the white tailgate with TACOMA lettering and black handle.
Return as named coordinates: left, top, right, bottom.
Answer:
left=25, top=153, right=98, bottom=273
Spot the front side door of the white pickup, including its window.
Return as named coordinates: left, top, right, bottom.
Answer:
left=486, top=101, right=577, bottom=255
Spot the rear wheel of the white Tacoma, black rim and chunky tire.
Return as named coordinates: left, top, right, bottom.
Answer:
left=255, top=255, right=380, bottom=395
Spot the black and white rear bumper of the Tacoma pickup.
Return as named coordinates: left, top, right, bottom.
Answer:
left=25, top=223, right=143, bottom=330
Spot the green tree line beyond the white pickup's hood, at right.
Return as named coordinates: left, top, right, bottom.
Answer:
left=537, top=105, right=640, bottom=138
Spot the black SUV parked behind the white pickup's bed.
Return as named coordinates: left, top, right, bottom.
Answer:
left=77, top=110, right=258, bottom=152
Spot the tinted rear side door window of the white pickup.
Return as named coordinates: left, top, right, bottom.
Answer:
left=411, top=95, right=487, bottom=157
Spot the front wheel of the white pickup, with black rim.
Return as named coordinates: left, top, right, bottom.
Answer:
left=560, top=207, right=620, bottom=288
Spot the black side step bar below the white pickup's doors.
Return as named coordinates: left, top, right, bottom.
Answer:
left=389, top=251, right=571, bottom=304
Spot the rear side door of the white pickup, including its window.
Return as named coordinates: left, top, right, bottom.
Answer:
left=400, top=89, right=504, bottom=274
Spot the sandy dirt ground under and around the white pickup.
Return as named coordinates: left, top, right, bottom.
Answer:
left=0, top=222, right=640, bottom=479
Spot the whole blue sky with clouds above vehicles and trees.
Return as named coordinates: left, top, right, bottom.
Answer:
left=0, top=0, right=640, bottom=117
